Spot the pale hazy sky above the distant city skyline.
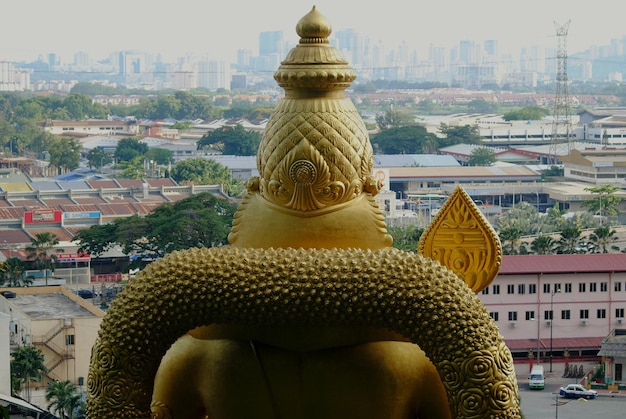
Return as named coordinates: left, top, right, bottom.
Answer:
left=0, top=0, right=626, bottom=62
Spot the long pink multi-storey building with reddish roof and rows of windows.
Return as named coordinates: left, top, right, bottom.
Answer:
left=479, top=253, right=626, bottom=381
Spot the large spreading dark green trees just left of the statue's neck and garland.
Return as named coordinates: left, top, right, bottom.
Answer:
left=75, top=193, right=237, bottom=268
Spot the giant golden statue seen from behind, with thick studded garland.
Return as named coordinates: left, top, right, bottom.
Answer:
left=87, top=7, right=520, bottom=419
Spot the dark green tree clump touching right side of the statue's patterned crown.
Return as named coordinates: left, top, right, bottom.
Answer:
left=371, top=125, right=439, bottom=154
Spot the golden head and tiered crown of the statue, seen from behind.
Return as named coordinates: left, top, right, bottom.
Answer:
left=224, top=7, right=392, bottom=249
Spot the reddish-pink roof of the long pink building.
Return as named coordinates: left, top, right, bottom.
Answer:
left=499, top=253, right=626, bottom=275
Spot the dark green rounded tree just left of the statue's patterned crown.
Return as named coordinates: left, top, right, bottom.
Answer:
left=197, top=124, right=261, bottom=156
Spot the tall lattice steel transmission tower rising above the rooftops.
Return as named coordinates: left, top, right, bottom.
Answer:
left=549, top=20, right=572, bottom=164
